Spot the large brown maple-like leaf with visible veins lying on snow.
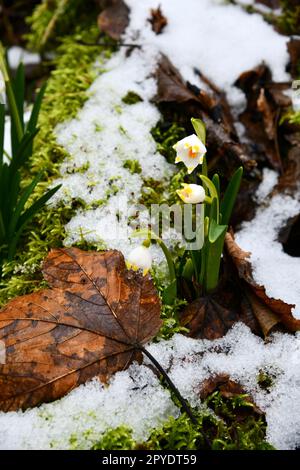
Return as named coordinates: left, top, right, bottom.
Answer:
left=0, top=248, right=161, bottom=411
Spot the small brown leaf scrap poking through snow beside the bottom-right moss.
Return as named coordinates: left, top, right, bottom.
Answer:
left=199, top=374, right=264, bottom=420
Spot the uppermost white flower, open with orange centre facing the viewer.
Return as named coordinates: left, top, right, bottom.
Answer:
left=173, top=134, right=206, bottom=173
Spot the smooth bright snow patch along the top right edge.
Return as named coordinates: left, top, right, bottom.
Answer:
left=126, top=0, right=289, bottom=102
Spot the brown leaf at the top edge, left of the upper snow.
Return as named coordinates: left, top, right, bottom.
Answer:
left=98, top=0, right=129, bottom=41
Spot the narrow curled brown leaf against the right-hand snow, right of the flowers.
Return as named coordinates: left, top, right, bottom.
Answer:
left=225, top=233, right=300, bottom=330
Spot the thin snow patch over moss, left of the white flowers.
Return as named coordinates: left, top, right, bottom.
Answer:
left=51, top=51, right=175, bottom=258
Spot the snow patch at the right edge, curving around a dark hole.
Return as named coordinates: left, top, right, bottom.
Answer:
left=236, top=170, right=300, bottom=318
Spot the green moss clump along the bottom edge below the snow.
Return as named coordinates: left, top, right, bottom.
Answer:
left=92, top=392, right=273, bottom=450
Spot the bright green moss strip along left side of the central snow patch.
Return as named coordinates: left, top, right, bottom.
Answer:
left=0, top=23, right=110, bottom=305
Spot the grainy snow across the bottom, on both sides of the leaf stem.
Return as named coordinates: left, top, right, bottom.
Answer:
left=0, top=323, right=300, bottom=449
